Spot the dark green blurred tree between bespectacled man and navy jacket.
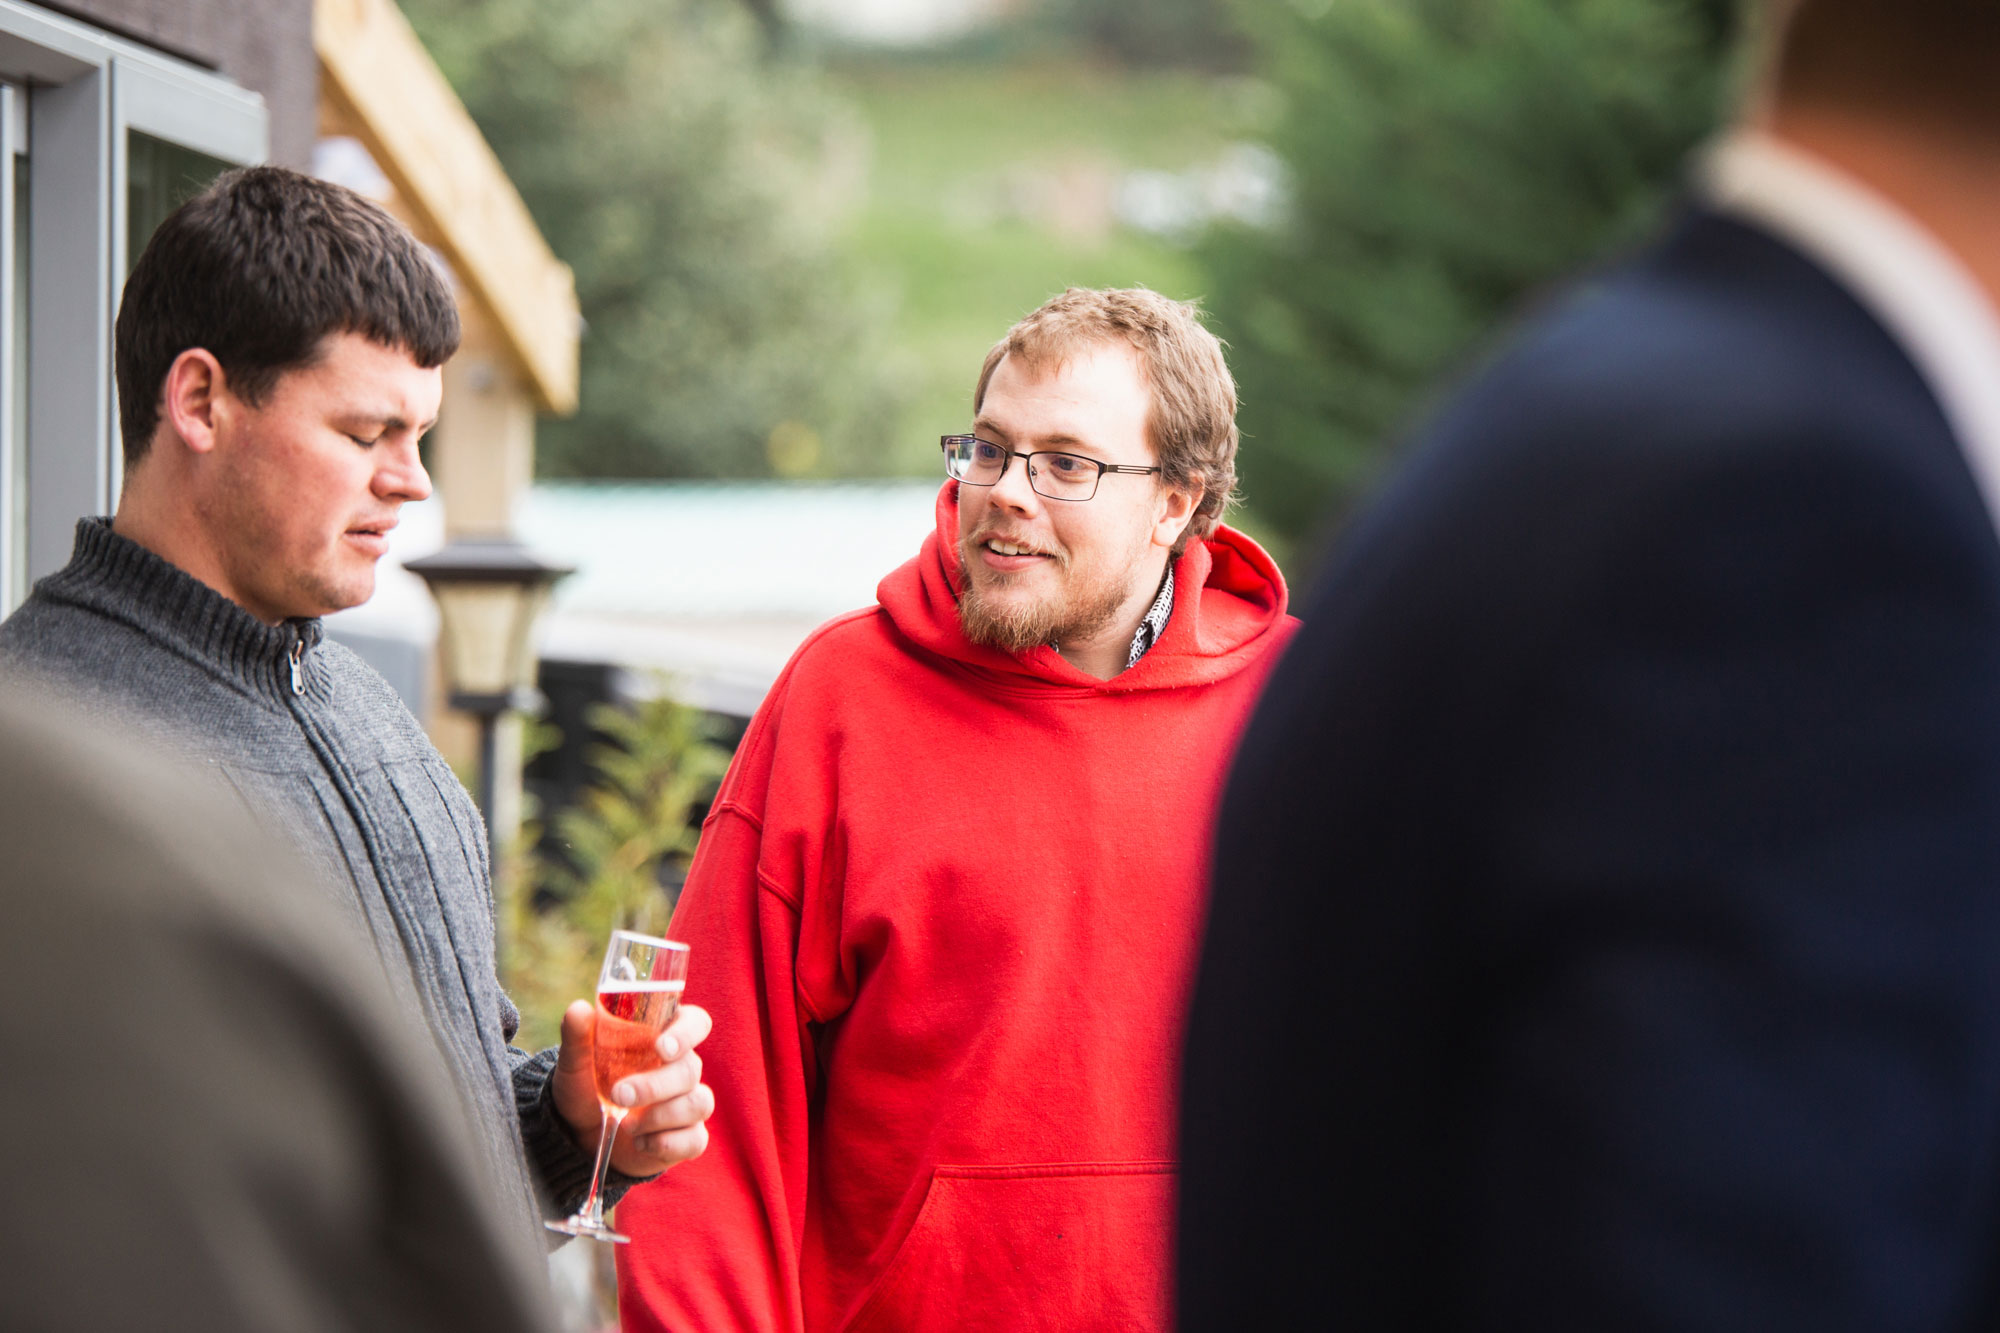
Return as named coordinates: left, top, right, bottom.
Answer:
left=1204, top=0, right=1734, bottom=534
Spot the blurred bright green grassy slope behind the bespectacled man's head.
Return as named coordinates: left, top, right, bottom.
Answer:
left=830, top=60, right=1258, bottom=474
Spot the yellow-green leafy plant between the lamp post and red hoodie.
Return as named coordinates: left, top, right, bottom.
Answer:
left=506, top=695, right=730, bottom=1051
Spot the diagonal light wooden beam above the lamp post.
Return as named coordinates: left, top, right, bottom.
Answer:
left=312, top=0, right=582, bottom=414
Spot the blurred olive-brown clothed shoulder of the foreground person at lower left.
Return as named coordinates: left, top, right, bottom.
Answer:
left=0, top=693, right=554, bottom=1333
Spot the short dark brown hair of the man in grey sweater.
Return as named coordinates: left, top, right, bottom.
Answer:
left=114, top=166, right=458, bottom=468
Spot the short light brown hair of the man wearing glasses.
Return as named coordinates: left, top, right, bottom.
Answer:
left=972, top=286, right=1238, bottom=554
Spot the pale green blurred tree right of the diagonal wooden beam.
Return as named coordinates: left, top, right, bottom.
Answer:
left=402, top=0, right=900, bottom=476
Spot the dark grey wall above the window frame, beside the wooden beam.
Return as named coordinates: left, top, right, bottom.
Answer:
left=42, top=0, right=320, bottom=170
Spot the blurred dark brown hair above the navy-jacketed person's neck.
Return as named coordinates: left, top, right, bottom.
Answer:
left=1776, top=0, right=2000, bottom=132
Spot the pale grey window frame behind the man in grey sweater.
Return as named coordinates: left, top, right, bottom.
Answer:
left=0, top=0, right=270, bottom=614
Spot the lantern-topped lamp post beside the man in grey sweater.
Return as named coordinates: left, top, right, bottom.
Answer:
left=404, top=538, right=576, bottom=885
